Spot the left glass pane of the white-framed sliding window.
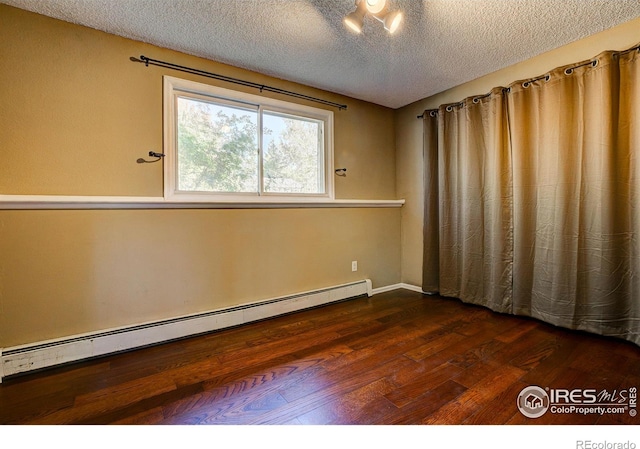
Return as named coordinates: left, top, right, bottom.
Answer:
left=177, top=97, right=259, bottom=193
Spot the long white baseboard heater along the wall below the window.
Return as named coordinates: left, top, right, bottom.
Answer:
left=0, top=279, right=373, bottom=382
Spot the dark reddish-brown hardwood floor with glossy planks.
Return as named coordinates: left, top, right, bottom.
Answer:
left=0, top=290, right=640, bottom=425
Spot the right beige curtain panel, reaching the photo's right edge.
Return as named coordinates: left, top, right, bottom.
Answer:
left=508, top=51, right=640, bottom=344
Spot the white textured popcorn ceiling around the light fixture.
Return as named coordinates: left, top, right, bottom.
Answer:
left=0, top=0, right=640, bottom=108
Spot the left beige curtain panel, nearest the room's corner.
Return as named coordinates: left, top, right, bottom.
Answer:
left=424, top=88, right=513, bottom=312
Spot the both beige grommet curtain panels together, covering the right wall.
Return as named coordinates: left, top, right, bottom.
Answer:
left=424, top=45, right=640, bottom=344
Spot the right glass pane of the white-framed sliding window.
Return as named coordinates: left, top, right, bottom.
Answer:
left=262, top=112, right=325, bottom=193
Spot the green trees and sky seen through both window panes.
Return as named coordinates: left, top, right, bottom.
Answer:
left=177, top=97, right=325, bottom=194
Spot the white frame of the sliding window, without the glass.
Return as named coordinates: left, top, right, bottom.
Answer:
left=163, top=76, right=335, bottom=203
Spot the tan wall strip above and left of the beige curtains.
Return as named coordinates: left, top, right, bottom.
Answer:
left=395, top=18, right=640, bottom=285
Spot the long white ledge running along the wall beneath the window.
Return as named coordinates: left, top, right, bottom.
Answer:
left=0, top=195, right=405, bottom=210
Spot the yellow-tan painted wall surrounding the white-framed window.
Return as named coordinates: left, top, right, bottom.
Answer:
left=0, top=5, right=401, bottom=347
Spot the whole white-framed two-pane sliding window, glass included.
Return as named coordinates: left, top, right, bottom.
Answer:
left=164, top=77, right=334, bottom=201
